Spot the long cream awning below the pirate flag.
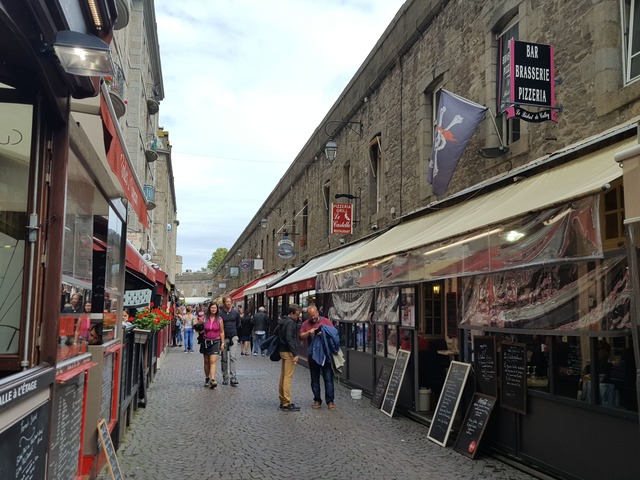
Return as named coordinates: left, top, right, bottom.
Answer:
left=320, top=138, right=637, bottom=278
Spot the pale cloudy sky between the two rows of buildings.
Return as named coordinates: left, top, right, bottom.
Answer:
left=155, top=0, right=404, bottom=270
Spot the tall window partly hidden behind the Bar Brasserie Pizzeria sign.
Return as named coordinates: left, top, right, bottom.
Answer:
left=496, top=22, right=520, bottom=145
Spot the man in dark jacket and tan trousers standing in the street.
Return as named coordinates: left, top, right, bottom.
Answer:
left=278, top=303, right=302, bottom=412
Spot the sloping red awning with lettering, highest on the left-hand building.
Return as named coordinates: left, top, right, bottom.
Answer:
left=100, top=94, right=149, bottom=228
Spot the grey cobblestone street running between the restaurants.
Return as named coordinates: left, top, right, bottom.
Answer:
left=98, top=348, right=534, bottom=480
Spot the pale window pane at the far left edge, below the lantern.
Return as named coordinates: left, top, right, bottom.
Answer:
left=0, top=92, right=33, bottom=355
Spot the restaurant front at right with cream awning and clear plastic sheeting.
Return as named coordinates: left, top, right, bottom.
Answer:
left=316, top=131, right=640, bottom=479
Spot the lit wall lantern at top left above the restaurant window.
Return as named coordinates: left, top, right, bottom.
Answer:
left=52, top=30, right=113, bottom=77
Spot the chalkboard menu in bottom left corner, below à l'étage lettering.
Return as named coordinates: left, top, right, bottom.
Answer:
left=0, top=402, right=51, bottom=480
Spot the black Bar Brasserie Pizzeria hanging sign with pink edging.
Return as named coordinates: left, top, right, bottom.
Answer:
left=501, top=38, right=558, bottom=122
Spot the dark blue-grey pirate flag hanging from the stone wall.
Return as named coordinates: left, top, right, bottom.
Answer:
left=427, top=90, right=487, bottom=195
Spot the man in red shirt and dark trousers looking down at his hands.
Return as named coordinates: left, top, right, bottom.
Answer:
left=300, top=305, right=339, bottom=410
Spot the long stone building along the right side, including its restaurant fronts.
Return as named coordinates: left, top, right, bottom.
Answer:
left=216, top=0, right=640, bottom=480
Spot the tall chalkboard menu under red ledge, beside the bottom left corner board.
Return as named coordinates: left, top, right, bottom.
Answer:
left=48, top=372, right=85, bottom=479
